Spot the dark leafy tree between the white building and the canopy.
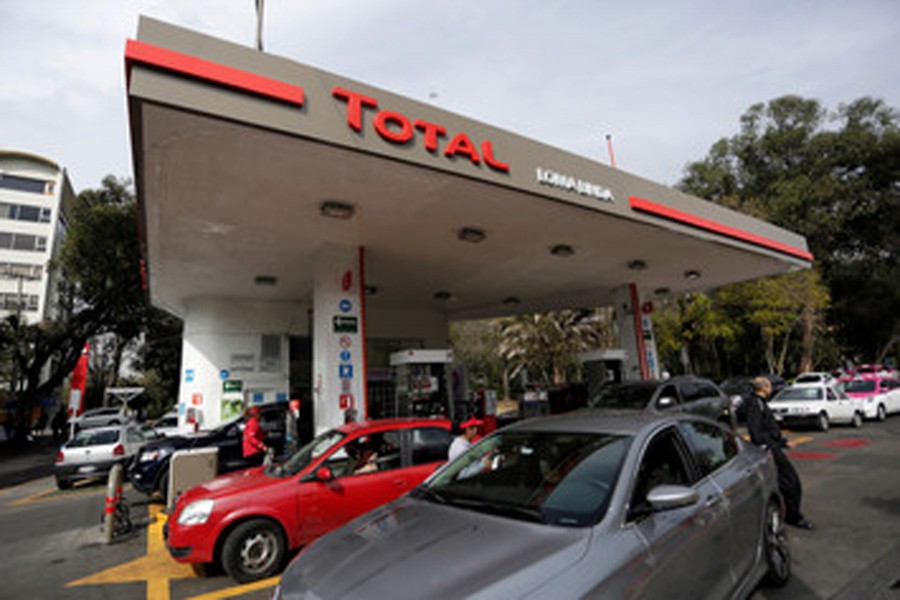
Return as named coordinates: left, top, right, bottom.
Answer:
left=0, top=176, right=148, bottom=440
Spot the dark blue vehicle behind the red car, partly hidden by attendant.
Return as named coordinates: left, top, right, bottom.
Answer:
left=130, top=403, right=287, bottom=500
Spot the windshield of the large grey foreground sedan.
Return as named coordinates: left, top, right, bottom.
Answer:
left=414, top=431, right=631, bottom=527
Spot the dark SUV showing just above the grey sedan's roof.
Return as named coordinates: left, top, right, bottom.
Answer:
left=588, top=376, right=734, bottom=425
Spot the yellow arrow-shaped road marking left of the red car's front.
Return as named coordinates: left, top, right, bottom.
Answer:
left=66, top=506, right=195, bottom=600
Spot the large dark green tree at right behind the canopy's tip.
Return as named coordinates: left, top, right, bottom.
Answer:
left=679, top=96, right=900, bottom=367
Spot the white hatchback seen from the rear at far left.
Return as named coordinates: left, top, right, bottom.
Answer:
left=54, top=424, right=148, bottom=490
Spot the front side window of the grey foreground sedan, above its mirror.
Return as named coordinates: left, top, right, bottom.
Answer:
left=629, top=427, right=693, bottom=515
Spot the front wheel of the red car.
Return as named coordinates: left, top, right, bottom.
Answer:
left=222, top=519, right=286, bottom=583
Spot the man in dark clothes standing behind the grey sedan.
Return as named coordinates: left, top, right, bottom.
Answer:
left=747, top=377, right=813, bottom=529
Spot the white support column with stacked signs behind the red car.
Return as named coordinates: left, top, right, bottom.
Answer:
left=313, top=244, right=368, bottom=434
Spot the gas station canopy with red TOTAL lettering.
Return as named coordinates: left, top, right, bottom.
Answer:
left=126, top=18, right=812, bottom=319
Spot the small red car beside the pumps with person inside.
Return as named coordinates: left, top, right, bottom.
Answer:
left=166, top=418, right=451, bottom=583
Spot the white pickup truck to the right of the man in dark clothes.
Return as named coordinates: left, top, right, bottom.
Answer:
left=769, top=383, right=863, bottom=431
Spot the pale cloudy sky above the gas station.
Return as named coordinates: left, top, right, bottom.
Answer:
left=0, top=0, right=900, bottom=192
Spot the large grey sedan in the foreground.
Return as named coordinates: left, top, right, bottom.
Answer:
left=273, top=410, right=791, bottom=600
